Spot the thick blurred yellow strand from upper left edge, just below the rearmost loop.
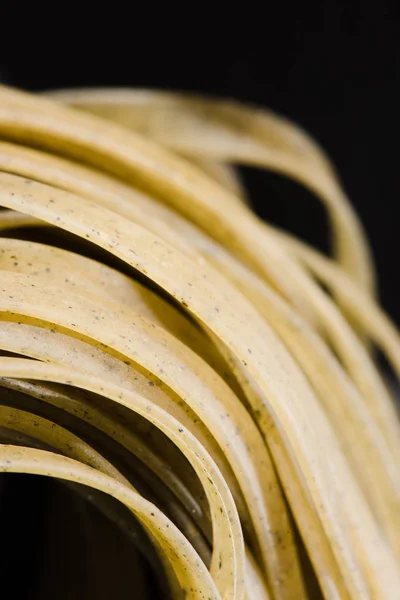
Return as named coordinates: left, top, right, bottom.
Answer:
left=0, top=88, right=364, bottom=332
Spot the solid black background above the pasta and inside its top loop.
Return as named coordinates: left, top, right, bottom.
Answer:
left=0, top=0, right=400, bottom=323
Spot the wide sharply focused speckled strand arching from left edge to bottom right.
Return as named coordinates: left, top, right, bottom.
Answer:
left=2, top=176, right=394, bottom=589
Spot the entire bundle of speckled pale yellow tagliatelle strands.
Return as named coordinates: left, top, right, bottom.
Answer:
left=0, top=87, right=400, bottom=600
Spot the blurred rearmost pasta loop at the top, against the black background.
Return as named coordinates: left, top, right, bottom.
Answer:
left=51, top=89, right=375, bottom=298
